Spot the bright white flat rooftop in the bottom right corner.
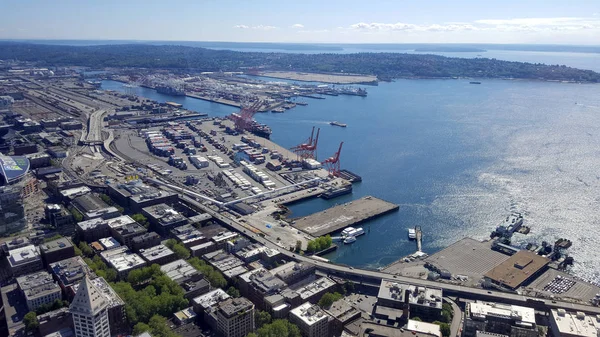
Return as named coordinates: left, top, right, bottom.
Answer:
left=551, top=309, right=600, bottom=337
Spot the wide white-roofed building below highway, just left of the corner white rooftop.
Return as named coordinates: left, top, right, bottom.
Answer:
left=463, top=301, right=538, bottom=337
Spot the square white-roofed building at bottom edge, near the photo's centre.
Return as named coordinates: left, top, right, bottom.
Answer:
left=290, top=302, right=330, bottom=337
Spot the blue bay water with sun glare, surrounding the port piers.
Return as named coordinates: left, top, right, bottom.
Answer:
left=103, top=80, right=600, bottom=278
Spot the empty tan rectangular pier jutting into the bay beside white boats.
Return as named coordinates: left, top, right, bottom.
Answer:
left=293, top=196, right=399, bottom=236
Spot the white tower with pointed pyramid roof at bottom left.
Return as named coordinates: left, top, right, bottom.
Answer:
left=69, top=276, right=110, bottom=337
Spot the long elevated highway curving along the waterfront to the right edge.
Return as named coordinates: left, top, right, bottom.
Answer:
left=151, top=183, right=600, bottom=315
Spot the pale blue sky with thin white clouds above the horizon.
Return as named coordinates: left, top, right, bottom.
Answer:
left=0, top=0, right=600, bottom=45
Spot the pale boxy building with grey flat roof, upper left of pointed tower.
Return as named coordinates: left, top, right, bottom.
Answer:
left=17, top=271, right=62, bottom=311
